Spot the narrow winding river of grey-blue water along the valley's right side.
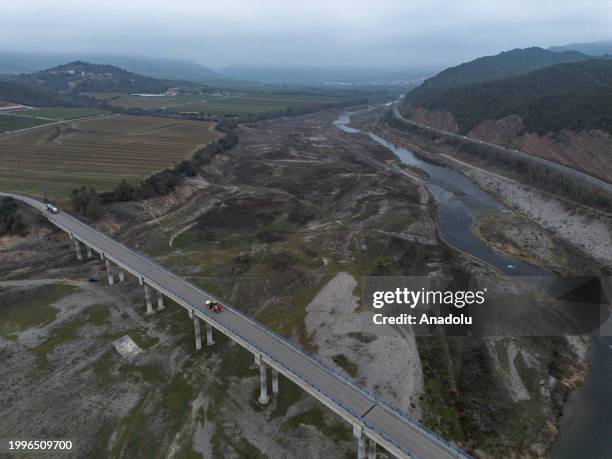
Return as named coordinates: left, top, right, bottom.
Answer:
left=334, top=109, right=612, bottom=459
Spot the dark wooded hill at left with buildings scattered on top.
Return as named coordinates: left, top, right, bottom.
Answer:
left=0, top=61, right=176, bottom=106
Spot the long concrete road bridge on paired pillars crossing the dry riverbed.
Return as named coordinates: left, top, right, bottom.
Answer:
left=0, top=193, right=470, bottom=459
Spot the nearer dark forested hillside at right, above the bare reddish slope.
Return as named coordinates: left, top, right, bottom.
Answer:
left=405, top=59, right=612, bottom=134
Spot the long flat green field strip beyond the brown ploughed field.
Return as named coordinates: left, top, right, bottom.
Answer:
left=85, top=93, right=341, bottom=115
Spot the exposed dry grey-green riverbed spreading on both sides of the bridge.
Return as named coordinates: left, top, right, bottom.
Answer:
left=0, top=107, right=596, bottom=458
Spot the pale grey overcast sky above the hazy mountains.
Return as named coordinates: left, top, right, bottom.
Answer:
left=0, top=0, right=612, bottom=68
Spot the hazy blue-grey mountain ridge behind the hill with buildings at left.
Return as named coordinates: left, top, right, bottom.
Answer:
left=0, top=52, right=227, bottom=83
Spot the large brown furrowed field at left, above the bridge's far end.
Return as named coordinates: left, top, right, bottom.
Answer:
left=0, top=115, right=220, bottom=202
